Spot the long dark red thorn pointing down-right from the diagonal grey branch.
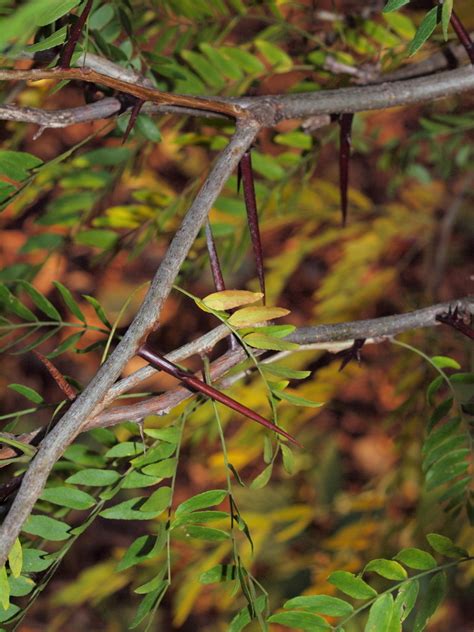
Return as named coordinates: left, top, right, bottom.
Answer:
left=137, top=345, right=302, bottom=448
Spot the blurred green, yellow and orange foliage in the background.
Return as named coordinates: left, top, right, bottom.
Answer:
left=0, top=0, right=474, bottom=632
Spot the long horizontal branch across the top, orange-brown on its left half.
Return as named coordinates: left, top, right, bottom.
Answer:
left=0, top=65, right=474, bottom=127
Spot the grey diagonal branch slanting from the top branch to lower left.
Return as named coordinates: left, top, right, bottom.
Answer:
left=0, top=119, right=259, bottom=567
